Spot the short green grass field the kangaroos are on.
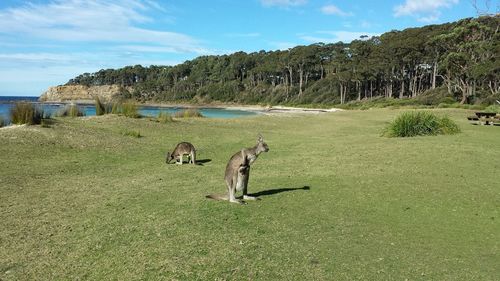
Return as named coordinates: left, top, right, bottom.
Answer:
left=0, top=109, right=500, bottom=280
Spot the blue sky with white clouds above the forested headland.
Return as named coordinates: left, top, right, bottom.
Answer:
left=0, top=0, right=484, bottom=96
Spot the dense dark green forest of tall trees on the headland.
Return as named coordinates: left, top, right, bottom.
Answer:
left=67, top=14, right=500, bottom=104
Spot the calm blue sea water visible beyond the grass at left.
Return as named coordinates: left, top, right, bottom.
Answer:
left=0, top=96, right=257, bottom=123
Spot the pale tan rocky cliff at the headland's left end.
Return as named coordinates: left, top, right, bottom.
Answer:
left=38, top=85, right=124, bottom=102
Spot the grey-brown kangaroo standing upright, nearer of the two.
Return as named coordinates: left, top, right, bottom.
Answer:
left=206, top=135, right=269, bottom=204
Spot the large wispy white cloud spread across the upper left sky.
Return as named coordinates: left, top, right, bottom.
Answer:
left=0, top=0, right=202, bottom=53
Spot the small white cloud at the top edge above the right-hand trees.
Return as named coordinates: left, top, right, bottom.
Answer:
left=394, top=0, right=458, bottom=22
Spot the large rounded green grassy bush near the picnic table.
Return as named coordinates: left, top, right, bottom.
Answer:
left=383, top=111, right=460, bottom=137
